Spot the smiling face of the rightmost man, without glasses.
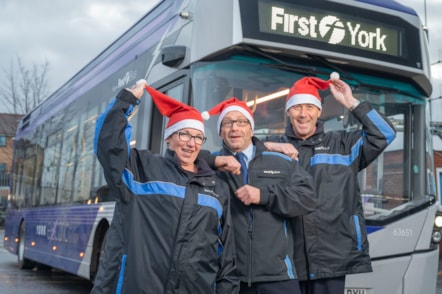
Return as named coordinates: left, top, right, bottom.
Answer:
left=287, top=104, right=321, bottom=140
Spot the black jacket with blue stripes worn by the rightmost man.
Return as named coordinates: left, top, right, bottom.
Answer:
left=270, top=102, right=396, bottom=280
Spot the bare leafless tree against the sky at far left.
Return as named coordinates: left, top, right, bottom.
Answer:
left=0, top=57, right=49, bottom=114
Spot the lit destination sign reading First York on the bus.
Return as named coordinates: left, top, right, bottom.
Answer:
left=258, top=1, right=403, bottom=57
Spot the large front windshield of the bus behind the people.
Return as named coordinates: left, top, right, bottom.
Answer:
left=191, top=57, right=434, bottom=225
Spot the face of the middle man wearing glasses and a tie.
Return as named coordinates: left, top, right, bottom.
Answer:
left=219, top=111, right=253, bottom=152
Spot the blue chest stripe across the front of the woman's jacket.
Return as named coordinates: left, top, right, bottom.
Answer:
left=123, top=169, right=223, bottom=218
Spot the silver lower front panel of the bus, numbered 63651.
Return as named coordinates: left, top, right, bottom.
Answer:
left=345, top=205, right=439, bottom=294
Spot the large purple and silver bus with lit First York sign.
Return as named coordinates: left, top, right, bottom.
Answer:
left=4, top=0, right=441, bottom=294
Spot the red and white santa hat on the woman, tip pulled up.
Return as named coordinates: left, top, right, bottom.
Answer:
left=144, top=85, right=204, bottom=139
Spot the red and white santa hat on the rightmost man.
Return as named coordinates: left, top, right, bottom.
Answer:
left=285, top=73, right=339, bottom=111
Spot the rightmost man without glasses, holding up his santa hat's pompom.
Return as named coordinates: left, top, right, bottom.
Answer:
left=265, top=73, right=396, bottom=294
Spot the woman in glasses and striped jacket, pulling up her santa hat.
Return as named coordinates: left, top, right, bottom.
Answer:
left=92, top=81, right=239, bottom=294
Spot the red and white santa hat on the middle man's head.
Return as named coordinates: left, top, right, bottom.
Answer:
left=202, top=97, right=255, bottom=134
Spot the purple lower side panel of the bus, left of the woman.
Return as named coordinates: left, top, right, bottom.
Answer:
left=5, top=202, right=115, bottom=279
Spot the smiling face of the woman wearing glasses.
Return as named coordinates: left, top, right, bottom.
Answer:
left=166, top=128, right=204, bottom=172
